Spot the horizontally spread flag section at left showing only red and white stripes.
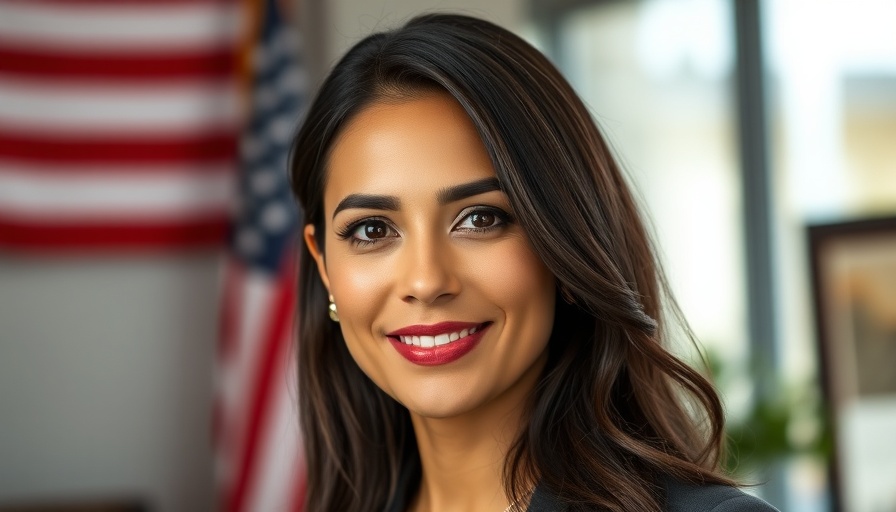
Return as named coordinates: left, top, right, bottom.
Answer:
left=0, top=0, right=243, bottom=252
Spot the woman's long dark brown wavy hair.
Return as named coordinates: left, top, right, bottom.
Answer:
left=291, top=14, right=730, bottom=512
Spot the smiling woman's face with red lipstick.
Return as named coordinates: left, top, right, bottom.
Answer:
left=305, top=92, right=555, bottom=418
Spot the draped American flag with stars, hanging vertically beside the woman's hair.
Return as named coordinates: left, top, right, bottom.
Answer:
left=216, top=0, right=306, bottom=512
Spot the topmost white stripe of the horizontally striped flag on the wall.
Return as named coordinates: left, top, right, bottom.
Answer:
left=0, top=2, right=243, bottom=52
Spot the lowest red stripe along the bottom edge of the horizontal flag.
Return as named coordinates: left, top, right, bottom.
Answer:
left=0, top=217, right=228, bottom=250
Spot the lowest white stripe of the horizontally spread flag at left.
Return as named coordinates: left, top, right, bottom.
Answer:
left=0, top=166, right=235, bottom=218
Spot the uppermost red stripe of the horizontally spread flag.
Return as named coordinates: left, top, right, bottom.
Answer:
left=0, top=44, right=236, bottom=83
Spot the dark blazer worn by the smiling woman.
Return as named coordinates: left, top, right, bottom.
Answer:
left=528, top=480, right=777, bottom=512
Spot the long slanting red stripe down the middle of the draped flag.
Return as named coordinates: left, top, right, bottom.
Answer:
left=225, top=275, right=295, bottom=512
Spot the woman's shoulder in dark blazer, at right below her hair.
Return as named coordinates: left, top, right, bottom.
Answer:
left=665, top=479, right=776, bottom=512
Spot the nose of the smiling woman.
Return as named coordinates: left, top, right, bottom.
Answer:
left=399, top=237, right=460, bottom=304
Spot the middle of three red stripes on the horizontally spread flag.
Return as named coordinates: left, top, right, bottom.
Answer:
left=0, top=127, right=237, bottom=166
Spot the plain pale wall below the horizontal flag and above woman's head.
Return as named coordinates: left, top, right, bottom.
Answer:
left=0, top=0, right=523, bottom=512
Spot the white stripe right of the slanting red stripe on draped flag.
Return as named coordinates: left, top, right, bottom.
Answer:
left=245, top=329, right=303, bottom=510
